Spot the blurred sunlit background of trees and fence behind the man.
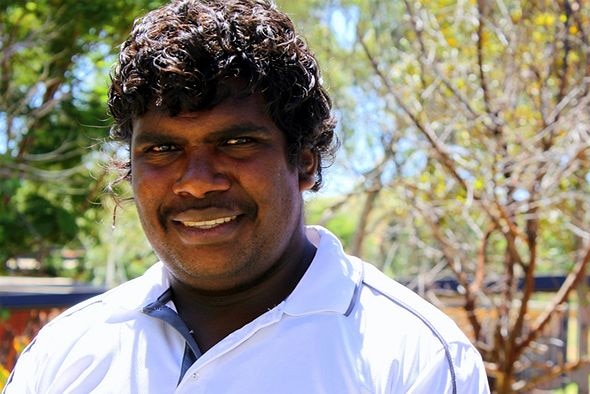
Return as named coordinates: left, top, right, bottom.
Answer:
left=0, top=0, right=590, bottom=393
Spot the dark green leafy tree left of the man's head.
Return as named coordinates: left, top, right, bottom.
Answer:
left=0, top=0, right=164, bottom=272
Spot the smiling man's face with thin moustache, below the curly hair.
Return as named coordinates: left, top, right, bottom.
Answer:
left=131, top=96, right=314, bottom=291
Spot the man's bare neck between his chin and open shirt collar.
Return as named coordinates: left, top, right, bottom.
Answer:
left=171, top=237, right=316, bottom=352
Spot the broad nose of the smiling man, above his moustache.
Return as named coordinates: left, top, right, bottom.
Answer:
left=173, top=149, right=231, bottom=198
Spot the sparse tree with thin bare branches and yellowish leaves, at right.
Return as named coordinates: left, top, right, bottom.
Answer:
left=280, top=0, right=590, bottom=393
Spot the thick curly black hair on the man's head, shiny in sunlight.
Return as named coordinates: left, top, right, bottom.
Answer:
left=108, top=0, right=338, bottom=190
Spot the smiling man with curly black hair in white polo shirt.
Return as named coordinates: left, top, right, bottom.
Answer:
left=6, top=0, right=488, bottom=394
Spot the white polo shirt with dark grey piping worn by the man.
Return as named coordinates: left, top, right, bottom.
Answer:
left=5, top=227, right=489, bottom=394
